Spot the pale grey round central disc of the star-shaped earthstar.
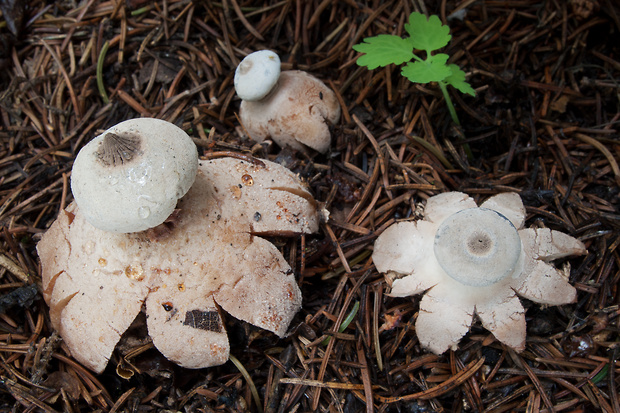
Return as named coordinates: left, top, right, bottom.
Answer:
left=434, top=208, right=521, bottom=286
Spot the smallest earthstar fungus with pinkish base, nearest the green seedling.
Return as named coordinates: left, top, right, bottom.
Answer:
left=235, top=50, right=340, bottom=153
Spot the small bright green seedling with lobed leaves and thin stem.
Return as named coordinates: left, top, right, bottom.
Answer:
left=353, top=12, right=476, bottom=125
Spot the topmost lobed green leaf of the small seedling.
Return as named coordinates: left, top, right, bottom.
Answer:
left=405, top=12, right=452, bottom=55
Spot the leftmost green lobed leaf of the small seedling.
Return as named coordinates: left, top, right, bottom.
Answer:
left=353, top=34, right=413, bottom=70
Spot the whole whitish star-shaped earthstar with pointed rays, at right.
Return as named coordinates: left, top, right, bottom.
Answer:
left=372, top=192, right=587, bottom=354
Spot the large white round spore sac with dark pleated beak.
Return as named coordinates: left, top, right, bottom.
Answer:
left=71, top=118, right=198, bottom=233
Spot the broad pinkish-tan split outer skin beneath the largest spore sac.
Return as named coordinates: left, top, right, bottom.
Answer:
left=37, top=158, right=318, bottom=372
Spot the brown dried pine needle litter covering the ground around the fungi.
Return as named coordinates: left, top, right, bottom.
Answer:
left=0, top=0, right=620, bottom=412
